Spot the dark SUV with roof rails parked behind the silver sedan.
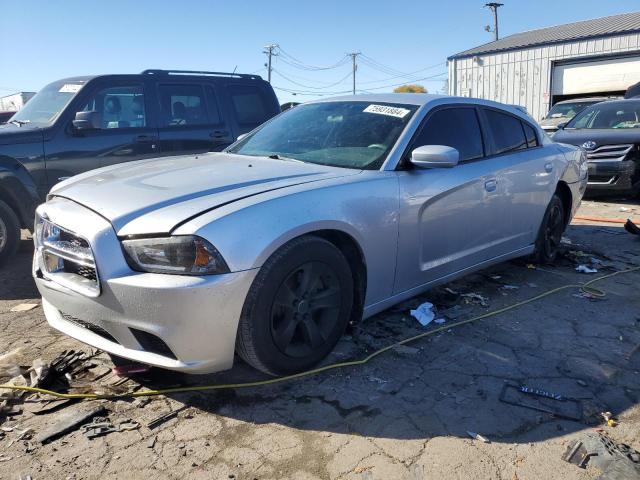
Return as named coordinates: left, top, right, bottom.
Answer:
left=0, top=70, right=280, bottom=262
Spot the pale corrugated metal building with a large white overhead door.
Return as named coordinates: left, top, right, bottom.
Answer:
left=448, top=12, right=640, bottom=120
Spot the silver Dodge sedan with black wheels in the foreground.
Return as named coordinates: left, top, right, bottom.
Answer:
left=33, top=94, right=587, bottom=375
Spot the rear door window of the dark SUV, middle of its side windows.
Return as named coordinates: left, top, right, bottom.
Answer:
left=158, top=85, right=212, bottom=127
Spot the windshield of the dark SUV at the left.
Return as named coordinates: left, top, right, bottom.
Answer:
left=11, top=81, right=84, bottom=126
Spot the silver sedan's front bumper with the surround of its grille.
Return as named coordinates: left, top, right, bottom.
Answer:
left=33, top=199, right=257, bottom=373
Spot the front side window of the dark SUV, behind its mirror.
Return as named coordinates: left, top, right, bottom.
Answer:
left=82, top=85, right=146, bottom=129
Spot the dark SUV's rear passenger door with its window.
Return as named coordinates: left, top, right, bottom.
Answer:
left=157, top=81, right=233, bottom=155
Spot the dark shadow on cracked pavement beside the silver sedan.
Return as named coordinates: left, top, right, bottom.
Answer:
left=130, top=225, right=640, bottom=442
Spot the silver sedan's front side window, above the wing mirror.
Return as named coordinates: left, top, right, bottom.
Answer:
left=412, top=108, right=484, bottom=161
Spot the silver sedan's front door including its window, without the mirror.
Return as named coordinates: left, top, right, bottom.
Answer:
left=394, top=105, right=505, bottom=293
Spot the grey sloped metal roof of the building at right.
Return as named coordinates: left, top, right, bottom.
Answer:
left=449, top=12, right=640, bottom=60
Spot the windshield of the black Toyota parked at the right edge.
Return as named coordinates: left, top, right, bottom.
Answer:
left=565, top=100, right=640, bottom=129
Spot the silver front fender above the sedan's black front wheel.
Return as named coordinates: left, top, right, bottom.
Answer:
left=172, top=171, right=399, bottom=304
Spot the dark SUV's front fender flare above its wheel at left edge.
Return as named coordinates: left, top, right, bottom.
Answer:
left=0, top=155, right=40, bottom=228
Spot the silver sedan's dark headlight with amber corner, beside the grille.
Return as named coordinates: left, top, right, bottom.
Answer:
left=122, top=235, right=229, bottom=275
